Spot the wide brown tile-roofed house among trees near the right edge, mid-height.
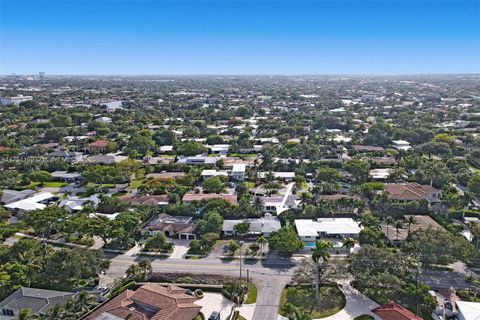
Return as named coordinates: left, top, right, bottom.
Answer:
left=385, top=182, right=441, bottom=202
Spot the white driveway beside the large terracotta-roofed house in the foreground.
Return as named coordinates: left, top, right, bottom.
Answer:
left=195, top=292, right=255, bottom=320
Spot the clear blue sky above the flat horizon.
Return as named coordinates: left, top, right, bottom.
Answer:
left=0, top=0, right=480, bottom=74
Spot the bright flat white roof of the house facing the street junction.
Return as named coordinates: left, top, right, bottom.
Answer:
left=295, top=218, right=362, bottom=237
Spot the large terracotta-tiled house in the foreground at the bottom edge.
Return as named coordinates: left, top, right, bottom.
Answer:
left=85, top=283, right=202, bottom=320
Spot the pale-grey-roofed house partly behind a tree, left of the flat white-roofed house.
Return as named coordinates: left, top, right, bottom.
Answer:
left=222, top=213, right=282, bottom=237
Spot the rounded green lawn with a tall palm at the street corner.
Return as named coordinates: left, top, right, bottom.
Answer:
left=279, top=286, right=346, bottom=319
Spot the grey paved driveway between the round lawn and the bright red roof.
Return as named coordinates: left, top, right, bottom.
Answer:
left=316, top=283, right=380, bottom=320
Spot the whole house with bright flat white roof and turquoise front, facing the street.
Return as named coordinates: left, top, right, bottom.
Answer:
left=294, top=218, right=363, bottom=251
